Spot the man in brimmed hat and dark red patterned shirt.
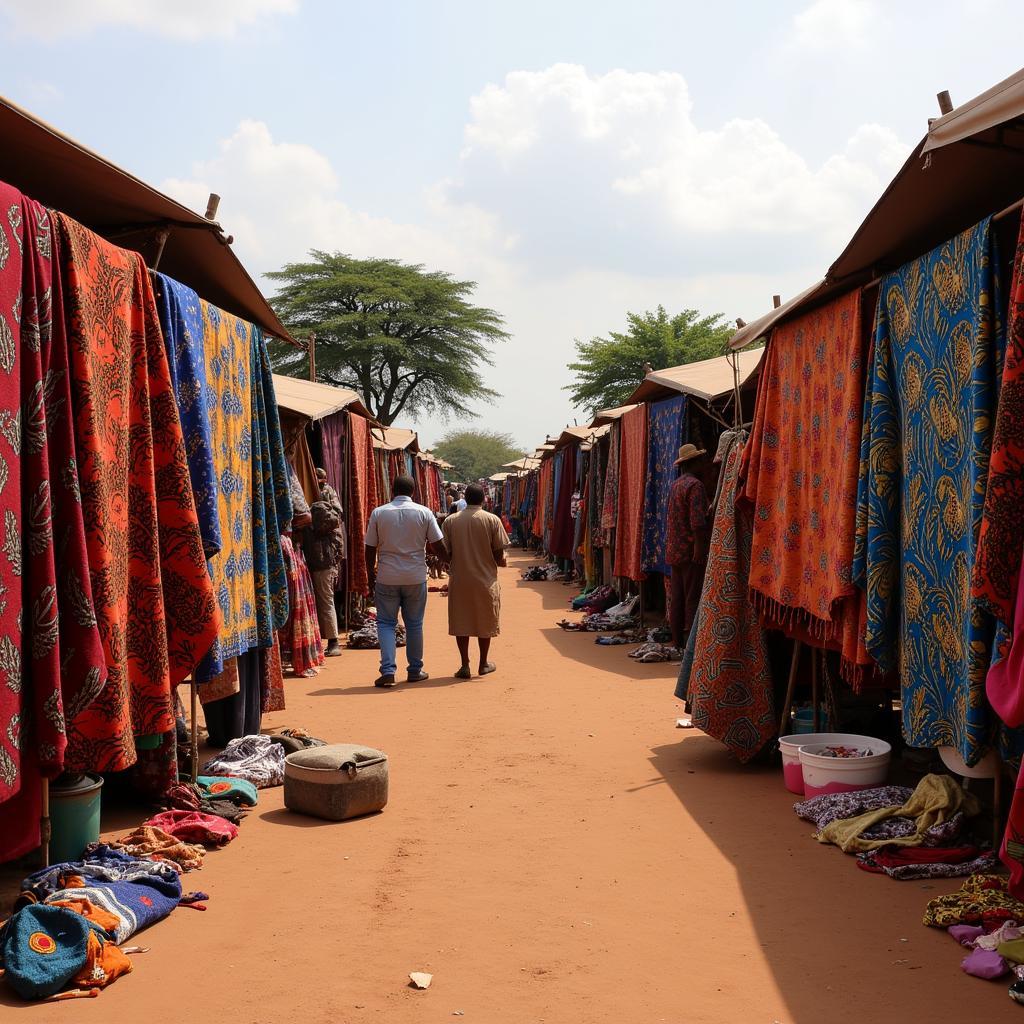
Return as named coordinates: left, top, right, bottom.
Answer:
left=665, top=444, right=708, bottom=647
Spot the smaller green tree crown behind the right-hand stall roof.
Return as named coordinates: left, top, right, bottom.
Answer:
left=563, top=306, right=732, bottom=413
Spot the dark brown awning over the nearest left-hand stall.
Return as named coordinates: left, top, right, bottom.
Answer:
left=0, top=96, right=297, bottom=344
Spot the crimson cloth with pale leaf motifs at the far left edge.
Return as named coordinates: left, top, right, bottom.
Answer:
left=0, top=185, right=25, bottom=802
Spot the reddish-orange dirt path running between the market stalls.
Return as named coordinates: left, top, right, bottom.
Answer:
left=0, top=557, right=1013, bottom=1024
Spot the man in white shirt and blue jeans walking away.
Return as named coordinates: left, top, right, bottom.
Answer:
left=365, top=476, right=447, bottom=688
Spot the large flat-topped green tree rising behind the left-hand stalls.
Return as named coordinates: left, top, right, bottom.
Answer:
left=267, top=250, right=508, bottom=424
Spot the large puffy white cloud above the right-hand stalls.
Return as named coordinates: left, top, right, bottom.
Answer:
left=444, top=65, right=906, bottom=272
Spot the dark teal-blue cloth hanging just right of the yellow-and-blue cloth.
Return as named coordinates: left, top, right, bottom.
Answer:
left=252, top=327, right=293, bottom=647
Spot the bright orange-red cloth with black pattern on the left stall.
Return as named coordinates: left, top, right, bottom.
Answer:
left=54, top=213, right=220, bottom=771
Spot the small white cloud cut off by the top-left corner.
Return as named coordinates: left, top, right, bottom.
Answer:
left=0, top=0, right=299, bottom=40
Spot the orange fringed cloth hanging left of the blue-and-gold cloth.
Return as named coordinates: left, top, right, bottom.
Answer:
left=743, top=289, right=870, bottom=678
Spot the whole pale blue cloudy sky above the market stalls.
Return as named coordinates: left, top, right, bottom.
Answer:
left=0, top=0, right=1024, bottom=447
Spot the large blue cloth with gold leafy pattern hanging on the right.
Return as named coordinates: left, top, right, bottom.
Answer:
left=854, top=220, right=999, bottom=765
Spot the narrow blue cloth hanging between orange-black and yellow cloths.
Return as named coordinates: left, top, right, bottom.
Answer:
left=153, top=273, right=220, bottom=558
